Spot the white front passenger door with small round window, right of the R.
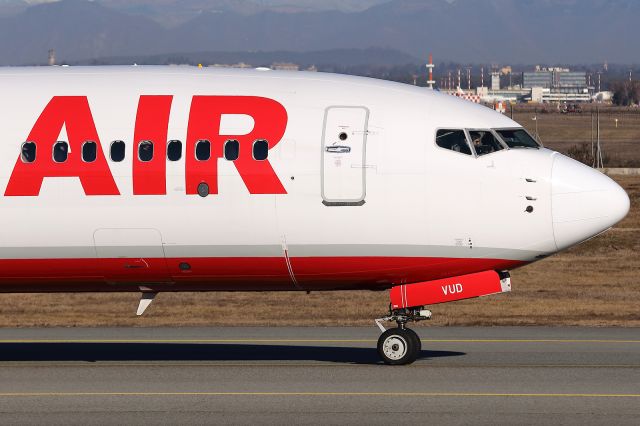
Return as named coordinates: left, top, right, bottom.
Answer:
left=322, top=106, right=369, bottom=206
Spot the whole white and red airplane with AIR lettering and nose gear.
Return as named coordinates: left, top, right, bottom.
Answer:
left=0, top=66, right=630, bottom=364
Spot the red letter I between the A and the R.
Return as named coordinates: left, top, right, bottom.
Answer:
left=131, top=96, right=173, bottom=195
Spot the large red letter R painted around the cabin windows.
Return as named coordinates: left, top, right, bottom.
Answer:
left=186, top=96, right=287, bottom=194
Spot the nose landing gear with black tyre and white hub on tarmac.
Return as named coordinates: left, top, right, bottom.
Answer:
left=375, top=308, right=431, bottom=365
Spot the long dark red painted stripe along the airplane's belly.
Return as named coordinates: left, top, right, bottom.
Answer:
left=0, top=257, right=524, bottom=292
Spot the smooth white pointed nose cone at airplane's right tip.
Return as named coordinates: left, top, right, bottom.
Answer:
left=551, top=154, right=630, bottom=250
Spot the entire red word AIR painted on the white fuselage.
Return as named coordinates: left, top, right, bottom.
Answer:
left=5, top=95, right=288, bottom=196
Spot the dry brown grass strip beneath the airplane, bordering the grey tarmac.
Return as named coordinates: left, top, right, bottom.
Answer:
left=0, top=176, right=640, bottom=327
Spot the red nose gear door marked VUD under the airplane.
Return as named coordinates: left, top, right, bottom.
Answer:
left=389, top=271, right=510, bottom=309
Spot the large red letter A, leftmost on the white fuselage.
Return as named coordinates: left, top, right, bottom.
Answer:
left=4, top=96, right=120, bottom=196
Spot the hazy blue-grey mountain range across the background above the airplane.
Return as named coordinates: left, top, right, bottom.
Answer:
left=0, top=0, right=640, bottom=65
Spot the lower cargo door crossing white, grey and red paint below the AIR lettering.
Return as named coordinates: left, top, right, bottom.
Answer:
left=93, top=229, right=171, bottom=284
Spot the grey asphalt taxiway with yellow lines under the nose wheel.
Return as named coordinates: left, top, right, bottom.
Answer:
left=0, top=325, right=640, bottom=425
